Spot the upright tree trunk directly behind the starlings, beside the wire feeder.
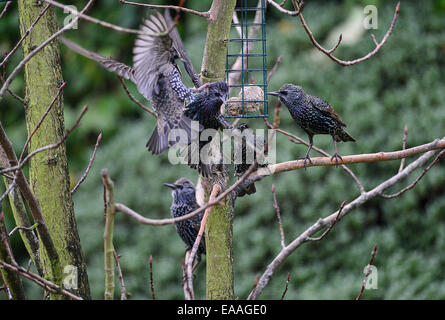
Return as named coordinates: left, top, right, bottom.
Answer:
left=201, top=0, right=236, bottom=300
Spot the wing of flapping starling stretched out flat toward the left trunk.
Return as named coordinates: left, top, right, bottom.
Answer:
left=59, top=37, right=136, bottom=82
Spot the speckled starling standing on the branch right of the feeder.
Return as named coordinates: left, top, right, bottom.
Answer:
left=267, top=84, right=355, bottom=166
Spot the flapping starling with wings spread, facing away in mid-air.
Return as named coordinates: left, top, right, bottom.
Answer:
left=61, top=11, right=196, bottom=154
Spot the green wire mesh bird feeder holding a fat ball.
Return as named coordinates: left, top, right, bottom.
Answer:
left=224, top=0, right=268, bottom=118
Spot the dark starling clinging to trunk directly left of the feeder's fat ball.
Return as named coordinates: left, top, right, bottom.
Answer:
left=184, top=81, right=231, bottom=177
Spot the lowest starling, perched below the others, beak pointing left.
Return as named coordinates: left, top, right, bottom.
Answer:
left=164, top=178, right=206, bottom=262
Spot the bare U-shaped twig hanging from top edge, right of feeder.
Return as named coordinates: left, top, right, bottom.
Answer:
left=292, top=0, right=400, bottom=66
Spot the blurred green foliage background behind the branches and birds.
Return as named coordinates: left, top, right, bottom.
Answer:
left=0, top=0, right=445, bottom=299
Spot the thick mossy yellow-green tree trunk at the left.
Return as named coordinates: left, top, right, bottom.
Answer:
left=18, top=0, right=90, bottom=299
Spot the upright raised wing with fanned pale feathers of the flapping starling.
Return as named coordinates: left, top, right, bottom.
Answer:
left=133, top=11, right=178, bottom=100
